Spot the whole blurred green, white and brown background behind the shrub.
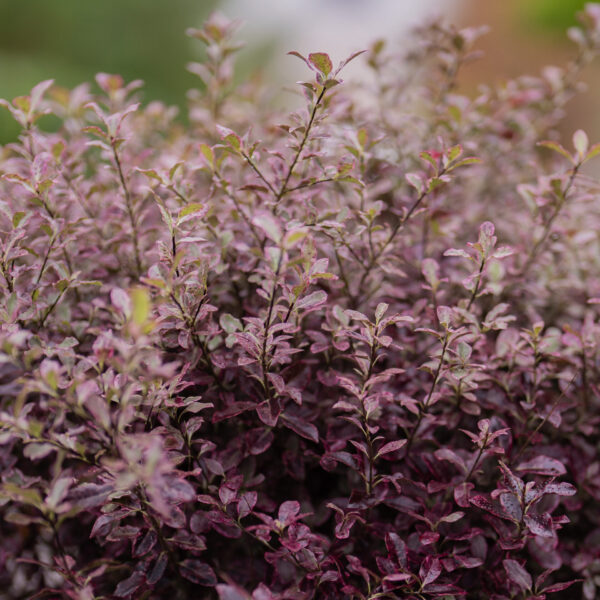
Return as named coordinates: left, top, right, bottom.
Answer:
left=0, top=0, right=600, bottom=143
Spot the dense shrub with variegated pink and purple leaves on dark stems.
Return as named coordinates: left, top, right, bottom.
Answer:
left=0, top=4, right=600, bottom=600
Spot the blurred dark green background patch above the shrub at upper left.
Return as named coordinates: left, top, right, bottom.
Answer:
left=0, top=0, right=217, bottom=143
